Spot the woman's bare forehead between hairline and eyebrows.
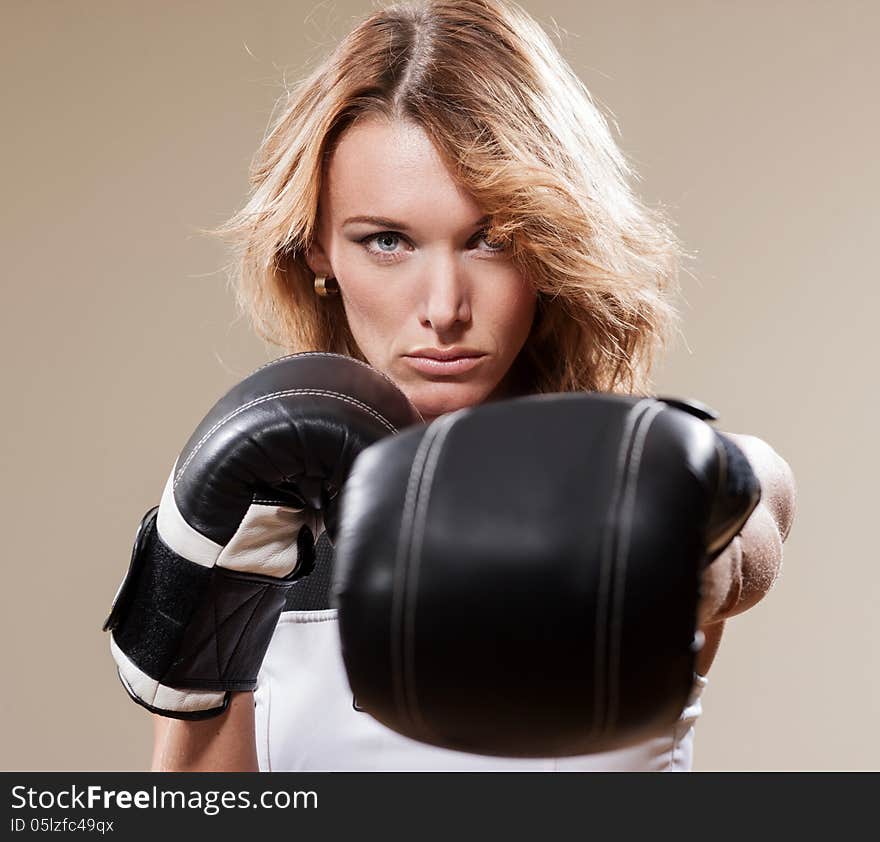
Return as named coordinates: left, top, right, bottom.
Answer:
left=322, top=118, right=479, bottom=219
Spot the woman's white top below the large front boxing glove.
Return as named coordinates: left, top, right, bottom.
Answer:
left=254, top=608, right=707, bottom=772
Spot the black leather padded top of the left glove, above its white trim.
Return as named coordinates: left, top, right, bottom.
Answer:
left=174, top=353, right=420, bottom=544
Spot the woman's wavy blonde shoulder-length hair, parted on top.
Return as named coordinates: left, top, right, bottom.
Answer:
left=213, top=0, right=683, bottom=394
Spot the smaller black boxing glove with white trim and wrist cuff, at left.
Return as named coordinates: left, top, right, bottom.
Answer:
left=104, top=353, right=421, bottom=719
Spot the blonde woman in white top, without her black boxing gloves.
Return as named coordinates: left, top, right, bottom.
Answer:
left=153, top=0, right=794, bottom=770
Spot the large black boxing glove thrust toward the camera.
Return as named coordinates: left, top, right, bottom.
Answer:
left=332, top=394, right=760, bottom=757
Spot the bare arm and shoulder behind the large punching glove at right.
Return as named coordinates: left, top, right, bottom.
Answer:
left=699, top=433, right=796, bottom=627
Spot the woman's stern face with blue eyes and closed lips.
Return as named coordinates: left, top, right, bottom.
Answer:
left=306, top=119, right=536, bottom=420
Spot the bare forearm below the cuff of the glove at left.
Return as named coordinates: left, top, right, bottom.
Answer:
left=152, top=693, right=259, bottom=772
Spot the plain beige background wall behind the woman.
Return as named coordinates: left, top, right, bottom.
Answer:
left=0, top=0, right=880, bottom=770
